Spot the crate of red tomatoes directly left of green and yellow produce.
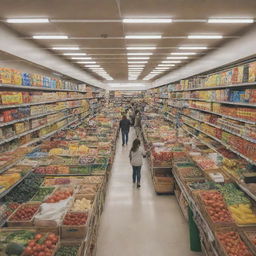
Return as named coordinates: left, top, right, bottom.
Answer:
left=198, top=190, right=234, bottom=230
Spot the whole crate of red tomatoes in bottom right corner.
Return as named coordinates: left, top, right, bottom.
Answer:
left=216, top=229, right=254, bottom=256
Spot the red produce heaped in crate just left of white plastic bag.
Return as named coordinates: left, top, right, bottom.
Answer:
left=9, top=204, right=39, bottom=221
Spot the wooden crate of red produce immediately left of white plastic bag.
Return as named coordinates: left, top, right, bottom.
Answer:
left=7, top=202, right=40, bottom=227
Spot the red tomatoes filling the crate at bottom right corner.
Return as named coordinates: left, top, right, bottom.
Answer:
left=217, top=231, right=253, bottom=256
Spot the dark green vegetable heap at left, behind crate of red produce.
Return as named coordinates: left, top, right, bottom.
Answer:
left=5, top=173, right=43, bottom=203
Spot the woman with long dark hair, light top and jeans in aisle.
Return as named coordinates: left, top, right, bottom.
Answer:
left=129, top=139, right=146, bottom=188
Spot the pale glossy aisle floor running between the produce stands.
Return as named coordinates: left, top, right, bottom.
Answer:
left=97, top=129, right=201, bottom=256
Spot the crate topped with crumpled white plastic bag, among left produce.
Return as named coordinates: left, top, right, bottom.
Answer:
left=34, top=197, right=72, bottom=227
